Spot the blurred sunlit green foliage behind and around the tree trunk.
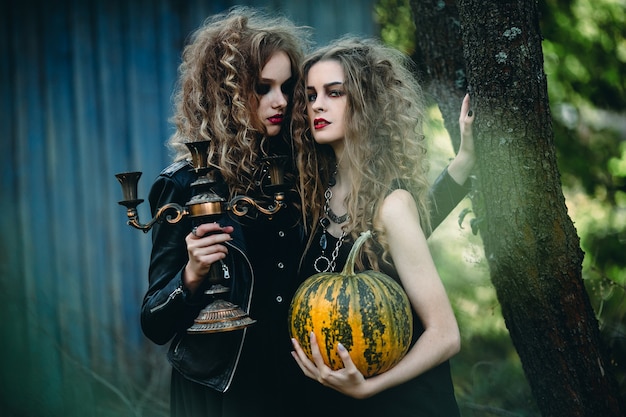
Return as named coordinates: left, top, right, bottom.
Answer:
left=375, top=0, right=626, bottom=417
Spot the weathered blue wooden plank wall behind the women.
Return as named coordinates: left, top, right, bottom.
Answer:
left=0, top=0, right=376, bottom=417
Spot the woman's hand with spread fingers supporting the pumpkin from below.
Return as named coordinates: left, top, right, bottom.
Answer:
left=291, top=333, right=374, bottom=399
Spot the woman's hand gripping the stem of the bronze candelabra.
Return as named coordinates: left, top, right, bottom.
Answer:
left=183, top=223, right=233, bottom=293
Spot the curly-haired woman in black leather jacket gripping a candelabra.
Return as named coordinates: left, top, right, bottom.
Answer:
left=141, top=4, right=473, bottom=416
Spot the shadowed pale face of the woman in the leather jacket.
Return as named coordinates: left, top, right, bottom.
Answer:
left=256, top=51, right=292, bottom=136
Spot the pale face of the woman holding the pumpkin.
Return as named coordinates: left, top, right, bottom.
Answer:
left=306, top=60, right=348, bottom=150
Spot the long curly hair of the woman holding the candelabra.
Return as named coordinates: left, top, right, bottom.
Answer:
left=168, top=7, right=310, bottom=200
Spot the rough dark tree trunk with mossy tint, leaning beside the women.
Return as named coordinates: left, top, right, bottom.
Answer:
left=412, top=0, right=626, bottom=417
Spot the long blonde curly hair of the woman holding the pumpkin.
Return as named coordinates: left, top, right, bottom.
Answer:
left=294, top=37, right=430, bottom=267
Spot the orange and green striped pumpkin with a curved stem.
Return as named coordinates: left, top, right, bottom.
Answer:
left=289, top=231, right=413, bottom=377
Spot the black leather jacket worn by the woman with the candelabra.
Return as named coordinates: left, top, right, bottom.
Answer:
left=141, top=161, right=467, bottom=392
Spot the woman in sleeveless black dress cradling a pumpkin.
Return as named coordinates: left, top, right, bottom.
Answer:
left=293, top=38, right=473, bottom=417
